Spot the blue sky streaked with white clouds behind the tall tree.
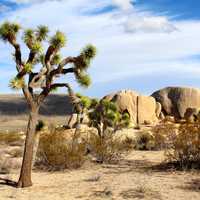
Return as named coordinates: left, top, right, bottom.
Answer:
left=0, top=0, right=200, bottom=97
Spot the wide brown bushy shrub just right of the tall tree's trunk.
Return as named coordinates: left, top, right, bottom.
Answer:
left=36, top=129, right=86, bottom=170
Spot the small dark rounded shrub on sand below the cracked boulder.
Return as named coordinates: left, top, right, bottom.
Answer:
left=135, top=131, right=155, bottom=150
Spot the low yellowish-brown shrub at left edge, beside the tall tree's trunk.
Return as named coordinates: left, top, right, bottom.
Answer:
left=0, top=133, right=23, bottom=145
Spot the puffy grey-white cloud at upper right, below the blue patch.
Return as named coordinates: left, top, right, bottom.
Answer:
left=125, top=16, right=177, bottom=33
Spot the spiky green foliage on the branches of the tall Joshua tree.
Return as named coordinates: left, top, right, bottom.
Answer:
left=0, top=22, right=96, bottom=91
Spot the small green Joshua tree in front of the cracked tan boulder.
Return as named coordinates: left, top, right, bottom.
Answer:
left=88, top=99, right=130, bottom=137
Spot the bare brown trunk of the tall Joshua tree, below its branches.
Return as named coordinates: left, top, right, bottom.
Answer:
left=17, top=106, right=39, bottom=187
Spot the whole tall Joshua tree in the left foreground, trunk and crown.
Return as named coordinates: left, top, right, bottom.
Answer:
left=0, top=22, right=96, bottom=187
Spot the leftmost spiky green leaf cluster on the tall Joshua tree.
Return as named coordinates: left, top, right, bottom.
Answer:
left=0, top=22, right=20, bottom=42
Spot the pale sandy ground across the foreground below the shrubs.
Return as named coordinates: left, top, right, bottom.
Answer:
left=0, top=151, right=200, bottom=200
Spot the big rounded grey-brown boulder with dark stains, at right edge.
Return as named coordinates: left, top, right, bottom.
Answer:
left=151, top=87, right=200, bottom=119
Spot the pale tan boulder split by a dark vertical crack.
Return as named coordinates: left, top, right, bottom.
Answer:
left=104, top=90, right=161, bottom=125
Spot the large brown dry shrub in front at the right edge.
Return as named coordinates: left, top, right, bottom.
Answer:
left=166, top=123, right=200, bottom=168
